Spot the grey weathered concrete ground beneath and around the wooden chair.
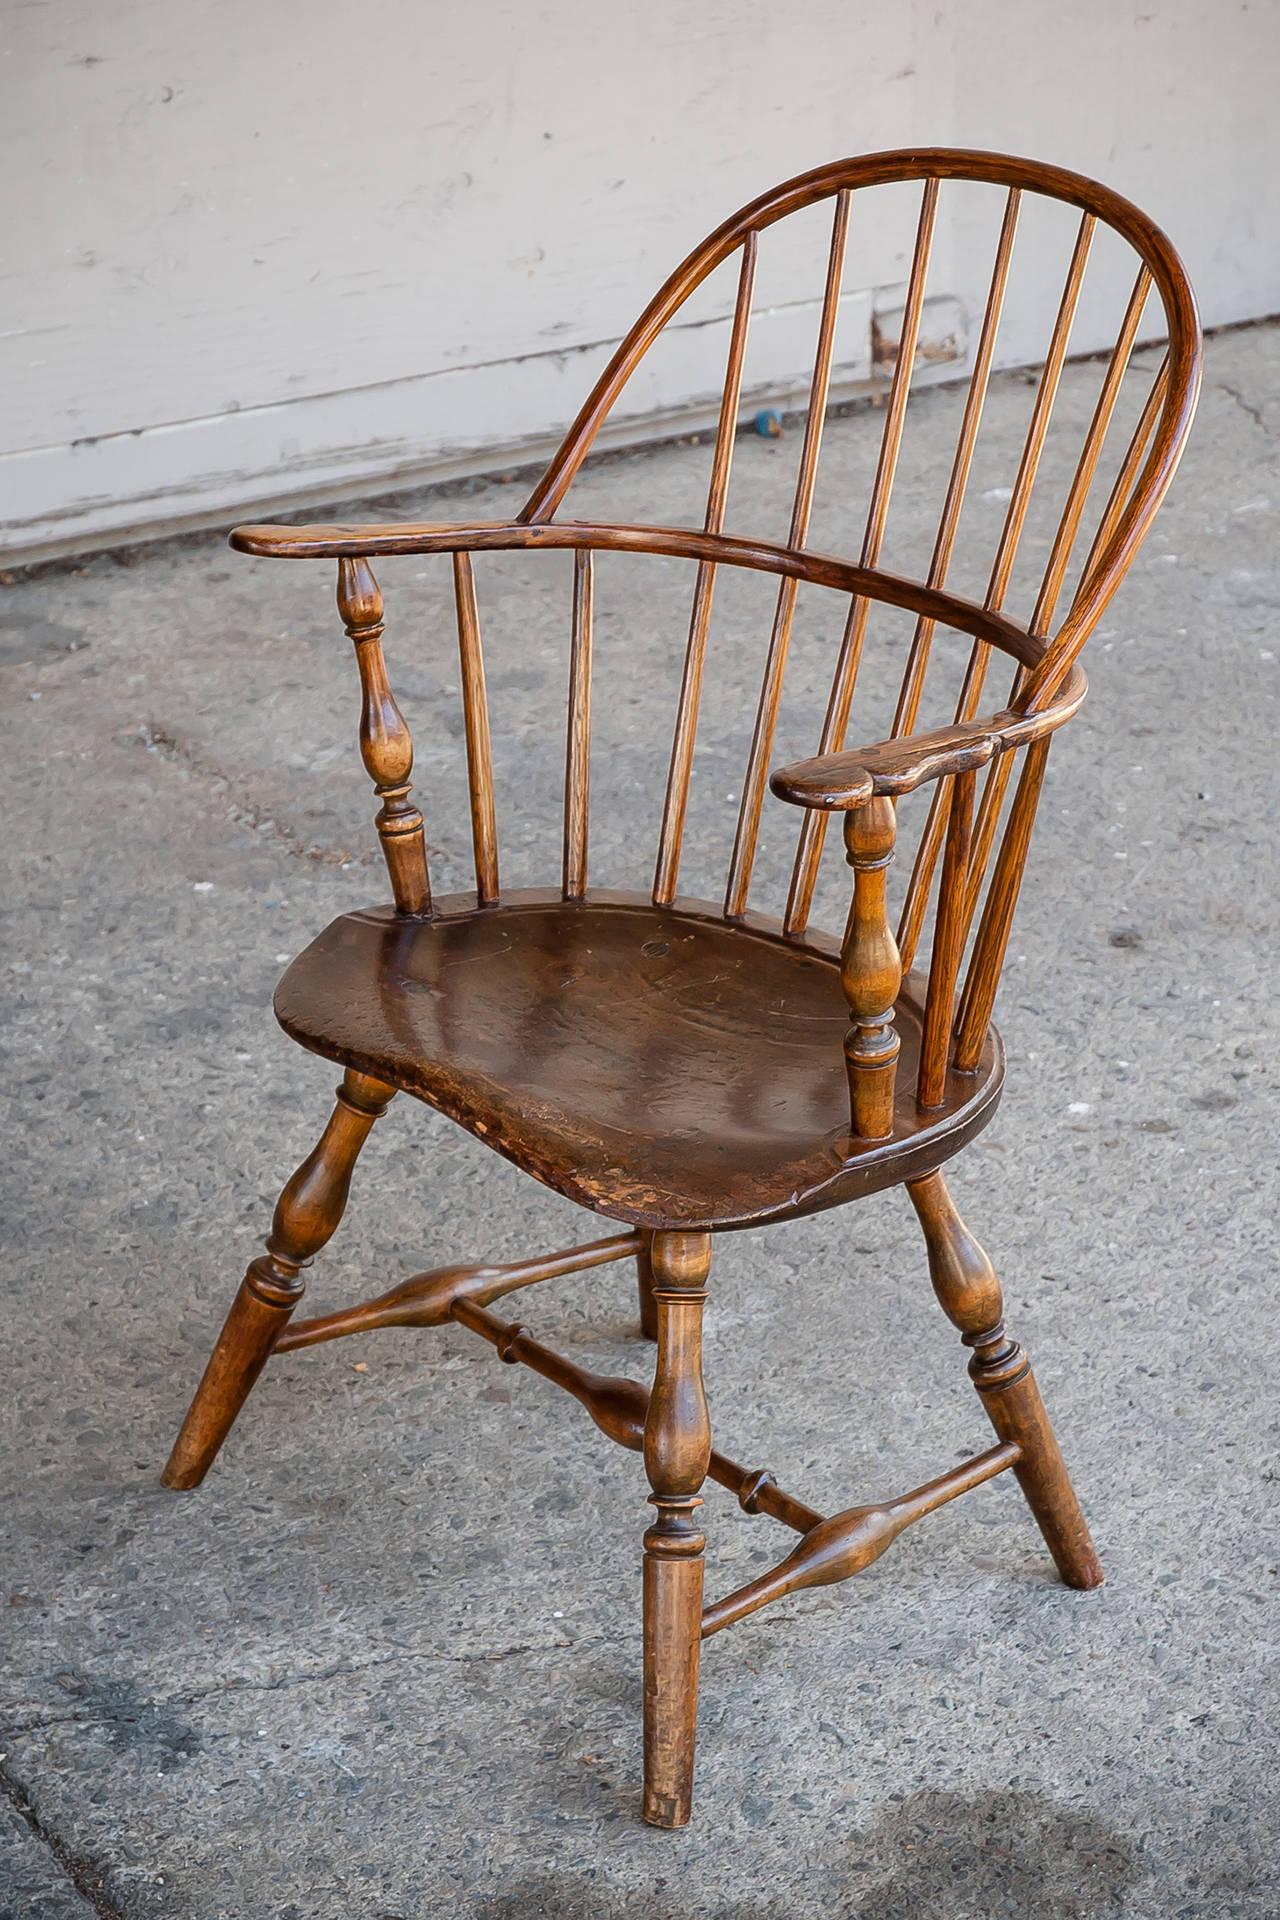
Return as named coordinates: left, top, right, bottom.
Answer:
left=0, top=326, right=1280, bottom=1920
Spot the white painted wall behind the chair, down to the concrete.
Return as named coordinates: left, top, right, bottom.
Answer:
left=0, top=0, right=1280, bottom=559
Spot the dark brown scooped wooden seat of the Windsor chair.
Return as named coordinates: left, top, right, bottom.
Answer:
left=276, top=893, right=1000, bottom=1231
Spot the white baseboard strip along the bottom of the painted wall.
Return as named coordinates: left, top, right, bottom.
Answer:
left=0, top=290, right=965, bottom=566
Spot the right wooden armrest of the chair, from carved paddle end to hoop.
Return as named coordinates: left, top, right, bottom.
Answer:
left=770, top=666, right=1088, bottom=812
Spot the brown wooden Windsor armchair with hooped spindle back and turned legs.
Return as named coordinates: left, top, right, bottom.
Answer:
left=165, top=150, right=1199, bottom=1826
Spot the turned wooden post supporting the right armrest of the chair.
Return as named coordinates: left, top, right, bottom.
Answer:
left=841, top=797, right=902, bottom=1140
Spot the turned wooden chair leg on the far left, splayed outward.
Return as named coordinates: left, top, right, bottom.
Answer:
left=163, top=1068, right=395, bottom=1490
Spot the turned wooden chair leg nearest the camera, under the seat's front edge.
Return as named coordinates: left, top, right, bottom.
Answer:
left=645, top=1233, right=712, bottom=1826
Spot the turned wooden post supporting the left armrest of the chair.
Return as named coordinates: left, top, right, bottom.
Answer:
left=338, top=561, right=432, bottom=918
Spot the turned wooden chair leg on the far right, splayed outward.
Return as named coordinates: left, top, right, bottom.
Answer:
left=908, top=1173, right=1103, bottom=1588
